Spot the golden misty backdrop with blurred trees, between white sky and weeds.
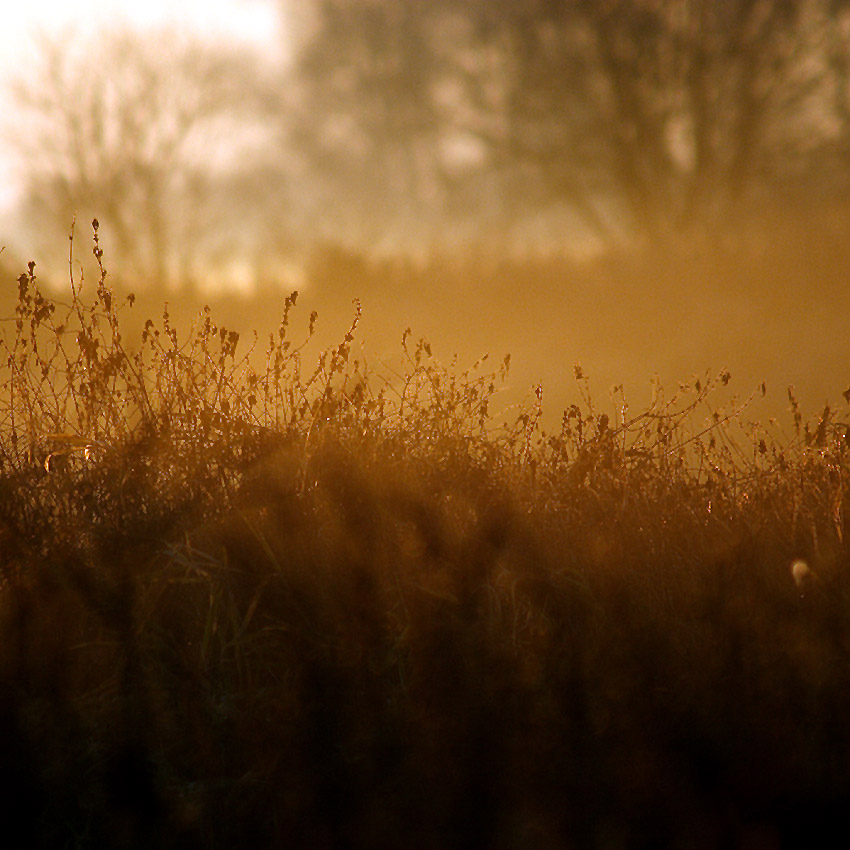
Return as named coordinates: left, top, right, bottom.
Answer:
left=0, top=0, right=850, bottom=418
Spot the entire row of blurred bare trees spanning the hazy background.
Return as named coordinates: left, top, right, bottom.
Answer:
left=6, top=0, right=850, bottom=281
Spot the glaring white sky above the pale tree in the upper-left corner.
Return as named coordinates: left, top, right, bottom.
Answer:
left=0, top=0, right=281, bottom=214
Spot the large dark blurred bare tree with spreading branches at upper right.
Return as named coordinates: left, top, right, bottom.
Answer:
left=568, top=0, right=840, bottom=231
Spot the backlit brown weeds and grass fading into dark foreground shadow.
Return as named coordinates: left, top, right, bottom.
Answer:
left=0, top=234, right=850, bottom=850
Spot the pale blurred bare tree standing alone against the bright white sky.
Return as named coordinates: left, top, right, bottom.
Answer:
left=9, top=30, right=278, bottom=284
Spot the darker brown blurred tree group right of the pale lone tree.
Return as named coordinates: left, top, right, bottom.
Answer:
left=290, top=0, right=850, bottom=242
